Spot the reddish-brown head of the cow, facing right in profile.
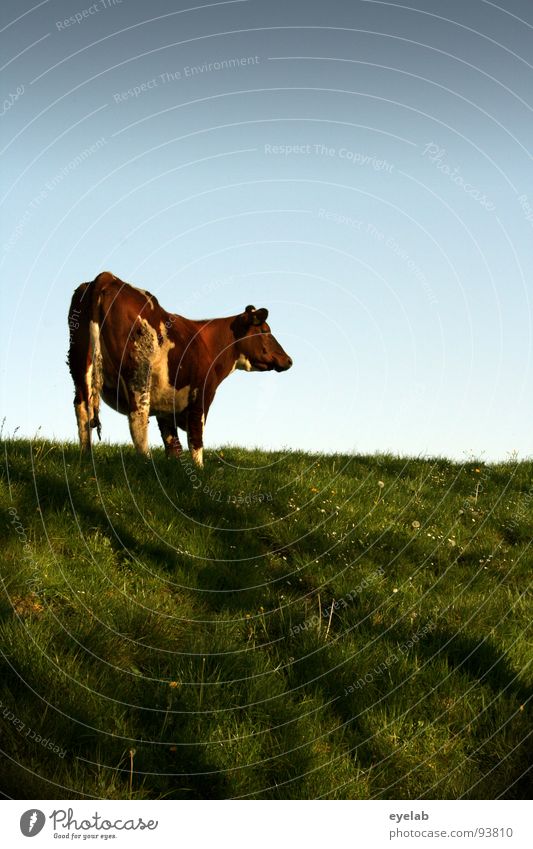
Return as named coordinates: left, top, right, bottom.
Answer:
left=231, top=306, right=292, bottom=371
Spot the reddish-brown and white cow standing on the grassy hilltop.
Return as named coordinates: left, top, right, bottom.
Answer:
left=67, top=271, right=292, bottom=467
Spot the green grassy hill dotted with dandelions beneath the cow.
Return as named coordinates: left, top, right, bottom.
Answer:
left=0, top=440, right=533, bottom=799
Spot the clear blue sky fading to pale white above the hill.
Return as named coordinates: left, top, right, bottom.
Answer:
left=0, top=0, right=533, bottom=460
